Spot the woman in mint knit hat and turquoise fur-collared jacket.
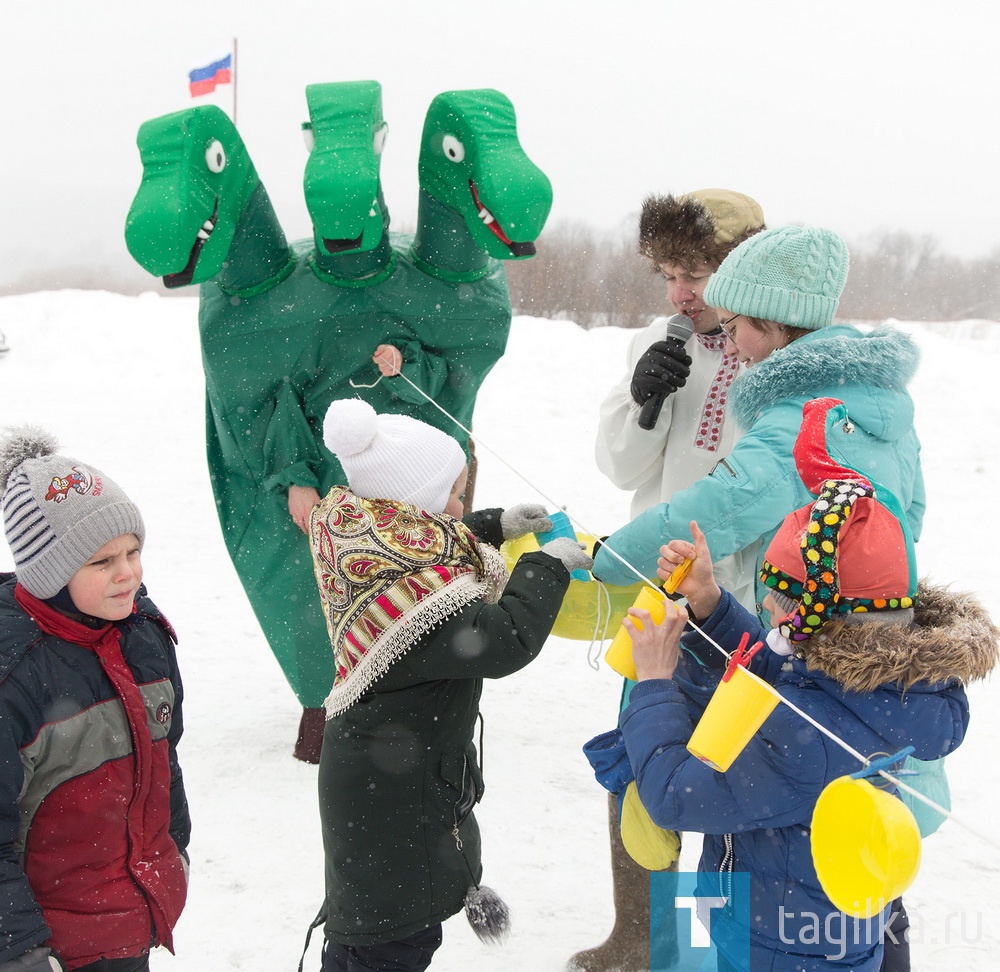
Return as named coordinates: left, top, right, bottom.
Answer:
left=594, top=226, right=924, bottom=611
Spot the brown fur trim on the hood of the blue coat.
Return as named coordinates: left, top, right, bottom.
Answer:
left=795, top=580, right=1000, bottom=692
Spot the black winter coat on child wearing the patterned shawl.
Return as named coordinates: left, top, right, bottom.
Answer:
left=319, top=510, right=570, bottom=945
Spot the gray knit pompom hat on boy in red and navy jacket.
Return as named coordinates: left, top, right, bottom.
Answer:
left=0, top=427, right=146, bottom=600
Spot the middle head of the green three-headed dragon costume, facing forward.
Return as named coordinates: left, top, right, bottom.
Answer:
left=303, top=81, right=389, bottom=253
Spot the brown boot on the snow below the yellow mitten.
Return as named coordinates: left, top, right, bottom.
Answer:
left=567, top=794, right=677, bottom=972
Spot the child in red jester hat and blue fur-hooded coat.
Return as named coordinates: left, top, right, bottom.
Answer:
left=584, top=398, right=1000, bottom=972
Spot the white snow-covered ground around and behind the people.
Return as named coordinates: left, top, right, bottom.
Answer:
left=0, top=291, right=1000, bottom=972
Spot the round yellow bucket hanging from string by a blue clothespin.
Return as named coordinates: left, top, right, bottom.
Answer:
left=810, top=776, right=920, bottom=918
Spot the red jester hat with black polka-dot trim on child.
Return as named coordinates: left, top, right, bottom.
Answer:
left=760, top=398, right=917, bottom=642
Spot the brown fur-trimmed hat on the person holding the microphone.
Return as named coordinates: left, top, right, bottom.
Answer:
left=639, top=189, right=764, bottom=269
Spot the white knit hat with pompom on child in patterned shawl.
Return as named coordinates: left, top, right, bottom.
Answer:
left=323, top=398, right=465, bottom=513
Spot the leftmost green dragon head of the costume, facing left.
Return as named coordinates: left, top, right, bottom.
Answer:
left=125, top=105, right=260, bottom=287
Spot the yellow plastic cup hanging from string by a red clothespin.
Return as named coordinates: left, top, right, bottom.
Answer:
left=687, top=662, right=778, bottom=773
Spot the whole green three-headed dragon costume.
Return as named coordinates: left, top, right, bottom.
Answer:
left=125, top=82, right=551, bottom=708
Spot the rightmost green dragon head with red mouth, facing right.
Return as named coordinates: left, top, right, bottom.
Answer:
left=419, top=88, right=552, bottom=260
